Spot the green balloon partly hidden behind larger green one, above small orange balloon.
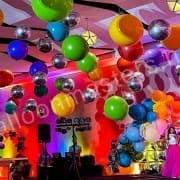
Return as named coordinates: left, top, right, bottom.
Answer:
left=76, top=52, right=97, bottom=73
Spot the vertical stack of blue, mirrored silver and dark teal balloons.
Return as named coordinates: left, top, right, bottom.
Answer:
left=29, top=61, right=48, bottom=97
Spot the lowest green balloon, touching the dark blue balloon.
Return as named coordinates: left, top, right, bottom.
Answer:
left=104, top=96, right=128, bottom=121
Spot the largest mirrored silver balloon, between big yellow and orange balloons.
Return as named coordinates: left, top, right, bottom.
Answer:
left=148, top=19, right=171, bottom=40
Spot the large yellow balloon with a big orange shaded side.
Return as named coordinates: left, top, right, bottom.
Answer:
left=109, top=14, right=144, bottom=46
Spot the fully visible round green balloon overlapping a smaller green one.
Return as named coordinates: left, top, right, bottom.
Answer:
left=62, top=35, right=89, bottom=61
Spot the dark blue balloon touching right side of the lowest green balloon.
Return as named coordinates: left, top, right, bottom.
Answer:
left=129, top=104, right=147, bottom=121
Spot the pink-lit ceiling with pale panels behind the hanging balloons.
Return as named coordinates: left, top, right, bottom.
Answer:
left=0, top=0, right=180, bottom=77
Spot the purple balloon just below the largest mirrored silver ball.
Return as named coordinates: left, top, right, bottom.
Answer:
left=143, top=49, right=164, bottom=67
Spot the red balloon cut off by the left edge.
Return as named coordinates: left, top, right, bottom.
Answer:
left=0, top=69, right=14, bottom=87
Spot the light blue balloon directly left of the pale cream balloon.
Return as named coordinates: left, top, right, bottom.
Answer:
left=125, top=126, right=142, bottom=142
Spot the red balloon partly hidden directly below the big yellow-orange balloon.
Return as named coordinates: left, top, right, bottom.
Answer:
left=118, top=41, right=144, bottom=61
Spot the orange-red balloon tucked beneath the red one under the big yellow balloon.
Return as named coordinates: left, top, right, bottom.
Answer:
left=117, top=57, right=135, bottom=72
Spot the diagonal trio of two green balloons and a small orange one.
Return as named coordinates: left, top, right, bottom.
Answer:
left=62, top=35, right=101, bottom=80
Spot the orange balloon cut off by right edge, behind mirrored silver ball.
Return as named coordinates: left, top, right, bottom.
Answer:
left=161, top=24, right=180, bottom=50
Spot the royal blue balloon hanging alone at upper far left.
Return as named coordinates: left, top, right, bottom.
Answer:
left=7, top=39, right=28, bottom=60
